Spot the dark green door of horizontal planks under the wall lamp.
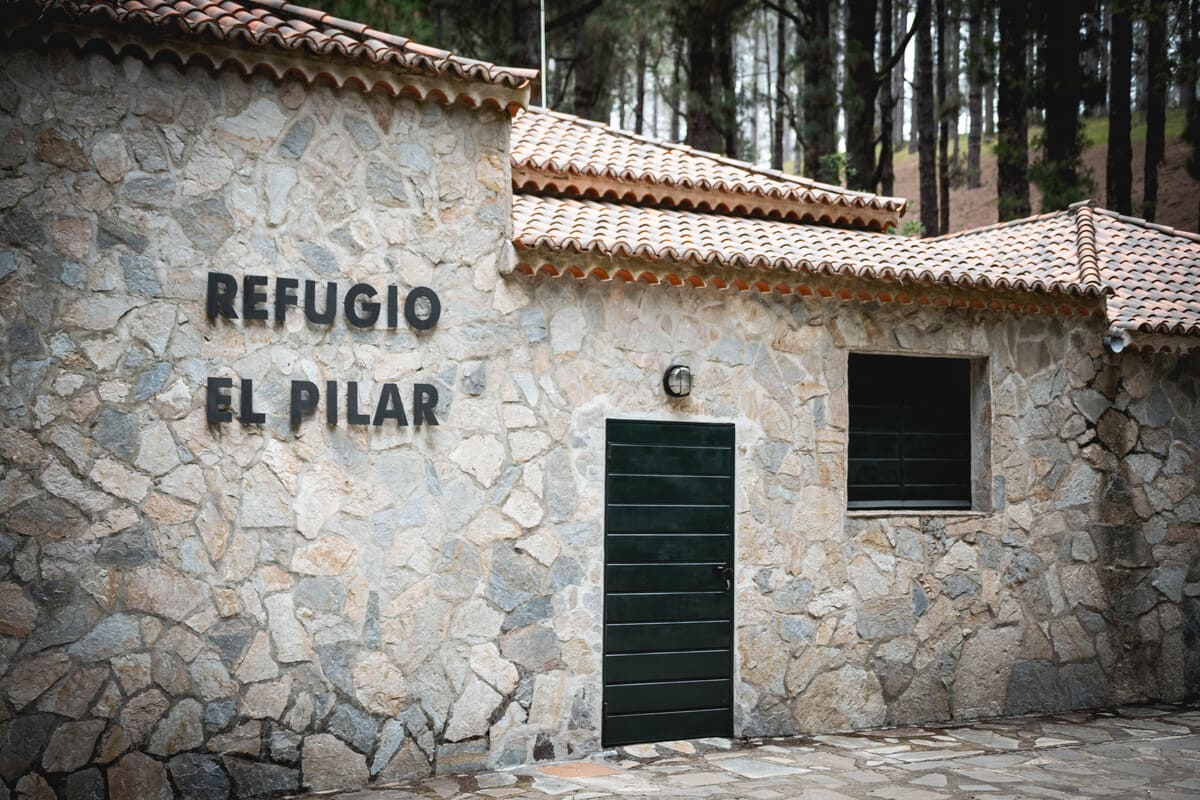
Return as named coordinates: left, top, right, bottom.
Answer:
left=601, top=420, right=733, bottom=745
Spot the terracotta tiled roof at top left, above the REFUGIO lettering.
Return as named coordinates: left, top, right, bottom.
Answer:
left=0, top=0, right=538, bottom=104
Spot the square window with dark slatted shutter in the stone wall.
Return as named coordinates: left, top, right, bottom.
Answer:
left=846, top=353, right=972, bottom=509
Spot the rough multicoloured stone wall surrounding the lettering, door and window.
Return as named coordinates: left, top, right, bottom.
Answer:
left=0, top=40, right=1200, bottom=798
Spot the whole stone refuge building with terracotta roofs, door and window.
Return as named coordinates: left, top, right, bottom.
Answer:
left=0, top=0, right=1200, bottom=800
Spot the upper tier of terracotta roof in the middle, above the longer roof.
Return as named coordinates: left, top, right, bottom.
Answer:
left=512, top=108, right=906, bottom=230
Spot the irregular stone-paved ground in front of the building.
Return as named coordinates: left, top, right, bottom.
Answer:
left=302, top=706, right=1200, bottom=800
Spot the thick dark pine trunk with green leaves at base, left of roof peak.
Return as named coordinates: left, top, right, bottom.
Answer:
left=1034, top=0, right=1087, bottom=212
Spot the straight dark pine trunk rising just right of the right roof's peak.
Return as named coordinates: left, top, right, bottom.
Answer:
left=1104, top=0, right=1133, bottom=213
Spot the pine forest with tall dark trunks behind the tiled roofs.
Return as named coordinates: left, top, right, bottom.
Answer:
left=318, top=0, right=1200, bottom=235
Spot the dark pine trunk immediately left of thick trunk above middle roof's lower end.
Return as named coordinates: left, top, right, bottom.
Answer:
left=798, top=0, right=838, bottom=184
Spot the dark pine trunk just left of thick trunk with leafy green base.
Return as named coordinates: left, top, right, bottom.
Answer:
left=996, top=0, right=1030, bottom=222
